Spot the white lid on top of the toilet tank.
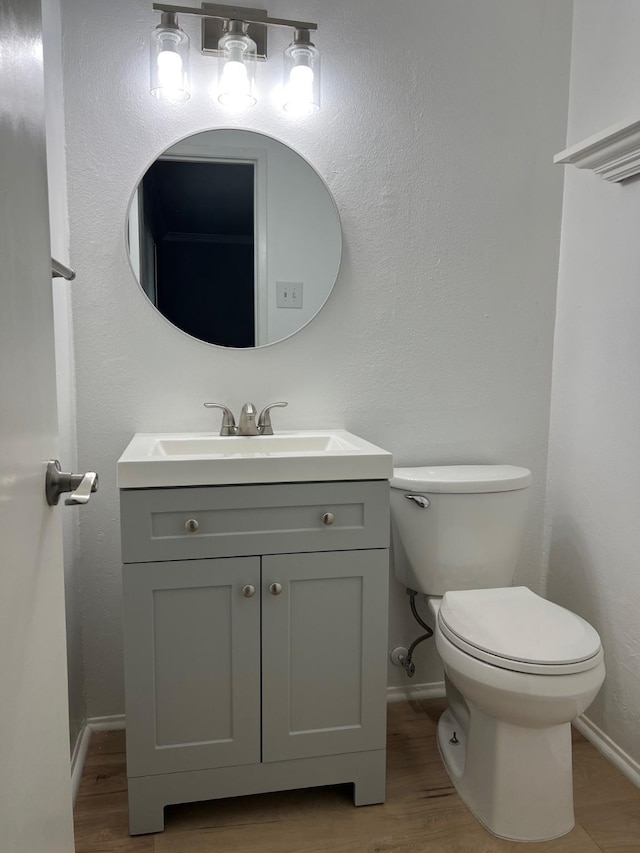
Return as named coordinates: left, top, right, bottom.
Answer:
left=391, top=465, right=533, bottom=494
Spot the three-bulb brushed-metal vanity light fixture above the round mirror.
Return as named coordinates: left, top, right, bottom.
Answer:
left=151, top=3, right=320, bottom=116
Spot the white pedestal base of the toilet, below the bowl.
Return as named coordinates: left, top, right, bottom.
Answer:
left=438, top=705, right=575, bottom=841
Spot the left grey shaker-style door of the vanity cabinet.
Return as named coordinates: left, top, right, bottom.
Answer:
left=124, top=557, right=260, bottom=776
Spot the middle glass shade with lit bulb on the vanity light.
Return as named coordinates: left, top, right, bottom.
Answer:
left=218, top=21, right=257, bottom=110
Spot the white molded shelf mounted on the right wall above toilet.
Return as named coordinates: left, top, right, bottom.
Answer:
left=553, top=119, right=640, bottom=181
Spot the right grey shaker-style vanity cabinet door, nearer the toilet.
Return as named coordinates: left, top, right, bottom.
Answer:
left=262, top=550, right=389, bottom=761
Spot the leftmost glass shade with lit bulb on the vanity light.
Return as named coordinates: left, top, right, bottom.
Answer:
left=150, top=13, right=190, bottom=102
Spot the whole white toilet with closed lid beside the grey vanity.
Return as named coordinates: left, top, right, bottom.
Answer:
left=391, top=465, right=605, bottom=841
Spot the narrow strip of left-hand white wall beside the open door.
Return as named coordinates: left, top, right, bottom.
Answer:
left=42, top=0, right=85, bottom=749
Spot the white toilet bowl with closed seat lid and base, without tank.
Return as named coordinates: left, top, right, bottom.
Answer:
left=430, top=587, right=605, bottom=841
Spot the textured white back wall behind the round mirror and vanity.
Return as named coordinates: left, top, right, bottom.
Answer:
left=63, top=0, right=571, bottom=715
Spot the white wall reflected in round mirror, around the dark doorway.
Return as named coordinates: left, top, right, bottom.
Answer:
left=165, top=130, right=342, bottom=345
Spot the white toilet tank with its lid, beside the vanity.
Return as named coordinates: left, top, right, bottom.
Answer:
left=391, top=465, right=532, bottom=595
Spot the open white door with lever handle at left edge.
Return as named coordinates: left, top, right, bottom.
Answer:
left=0, top=0, right=73, bottom=853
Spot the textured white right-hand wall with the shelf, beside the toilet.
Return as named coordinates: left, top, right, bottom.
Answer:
left=548, top=0, right=640, bottom=761
